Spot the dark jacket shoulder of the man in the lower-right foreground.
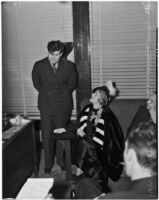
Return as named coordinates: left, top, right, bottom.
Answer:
left=100, top=176, right=157, bottom=199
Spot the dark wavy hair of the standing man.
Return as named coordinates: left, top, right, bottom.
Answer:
left=47, top=40, right=64, bottom=52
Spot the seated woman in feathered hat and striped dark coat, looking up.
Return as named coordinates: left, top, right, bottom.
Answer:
left=76, top=81, right=124, bottom=192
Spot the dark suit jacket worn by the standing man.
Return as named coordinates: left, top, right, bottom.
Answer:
left=32, top=57, right=77, bottom=114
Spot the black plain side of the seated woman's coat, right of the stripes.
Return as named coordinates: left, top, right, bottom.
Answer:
left=104, top=110, right=124, bottom=181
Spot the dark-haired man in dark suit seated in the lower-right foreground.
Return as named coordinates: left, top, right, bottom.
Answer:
left=76, top=122, right=157, bottom=199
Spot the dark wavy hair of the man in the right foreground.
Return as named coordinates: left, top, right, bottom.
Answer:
left=126, top=122, right=157, bottom=174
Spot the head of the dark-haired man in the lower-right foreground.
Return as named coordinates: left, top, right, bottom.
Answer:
left=124, top=122, right=157, bottom=180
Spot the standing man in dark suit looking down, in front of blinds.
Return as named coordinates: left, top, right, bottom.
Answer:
left=32, top=40, right=77, bottom=174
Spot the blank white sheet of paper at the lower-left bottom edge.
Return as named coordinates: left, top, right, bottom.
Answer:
left=16, top=178, right=54, bottom=200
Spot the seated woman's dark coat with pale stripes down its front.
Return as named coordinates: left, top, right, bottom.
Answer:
left=75, top=104, right=124, bottom=184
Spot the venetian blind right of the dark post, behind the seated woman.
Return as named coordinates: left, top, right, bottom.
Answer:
left=90, top=2, right=157, bottom=99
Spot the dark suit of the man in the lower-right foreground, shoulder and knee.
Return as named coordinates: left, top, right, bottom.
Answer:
left=75, top=176, right=157, bottom=199
